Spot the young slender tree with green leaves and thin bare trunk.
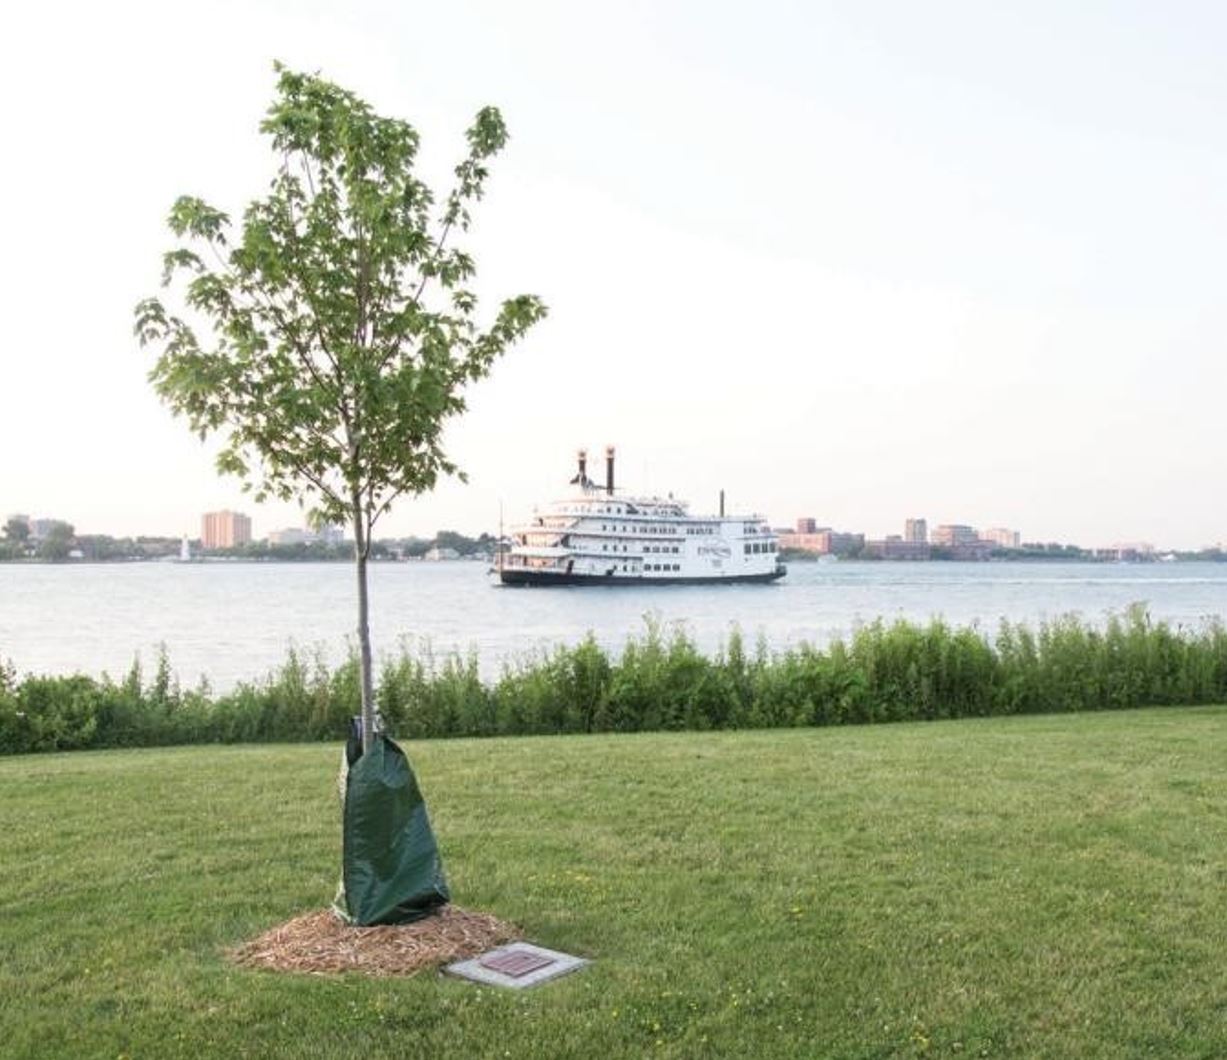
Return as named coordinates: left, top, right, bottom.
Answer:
left=135, top=64, right=546, bottom=747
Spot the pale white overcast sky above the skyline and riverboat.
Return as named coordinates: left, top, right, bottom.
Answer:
left=0, top=0, right=1227, bottom=547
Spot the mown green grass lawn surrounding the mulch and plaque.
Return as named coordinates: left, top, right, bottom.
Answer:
left=0, top=708, right=1227, bottom=1060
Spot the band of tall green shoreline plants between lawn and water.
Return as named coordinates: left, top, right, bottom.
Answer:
left=0, top=605, right=1227, bottom=755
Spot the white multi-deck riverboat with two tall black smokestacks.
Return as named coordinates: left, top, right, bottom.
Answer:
left=496, top=447, right=785, bottom=585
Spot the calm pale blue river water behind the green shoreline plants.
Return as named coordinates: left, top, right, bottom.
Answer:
left=0, top=562, right=1227, bottom=688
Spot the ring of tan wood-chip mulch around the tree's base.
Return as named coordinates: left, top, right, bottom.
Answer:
left=229, top=905, right=520, bottom=975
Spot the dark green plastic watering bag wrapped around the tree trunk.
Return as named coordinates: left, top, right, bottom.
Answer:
left=334, top=731, right=452, bottom=926
